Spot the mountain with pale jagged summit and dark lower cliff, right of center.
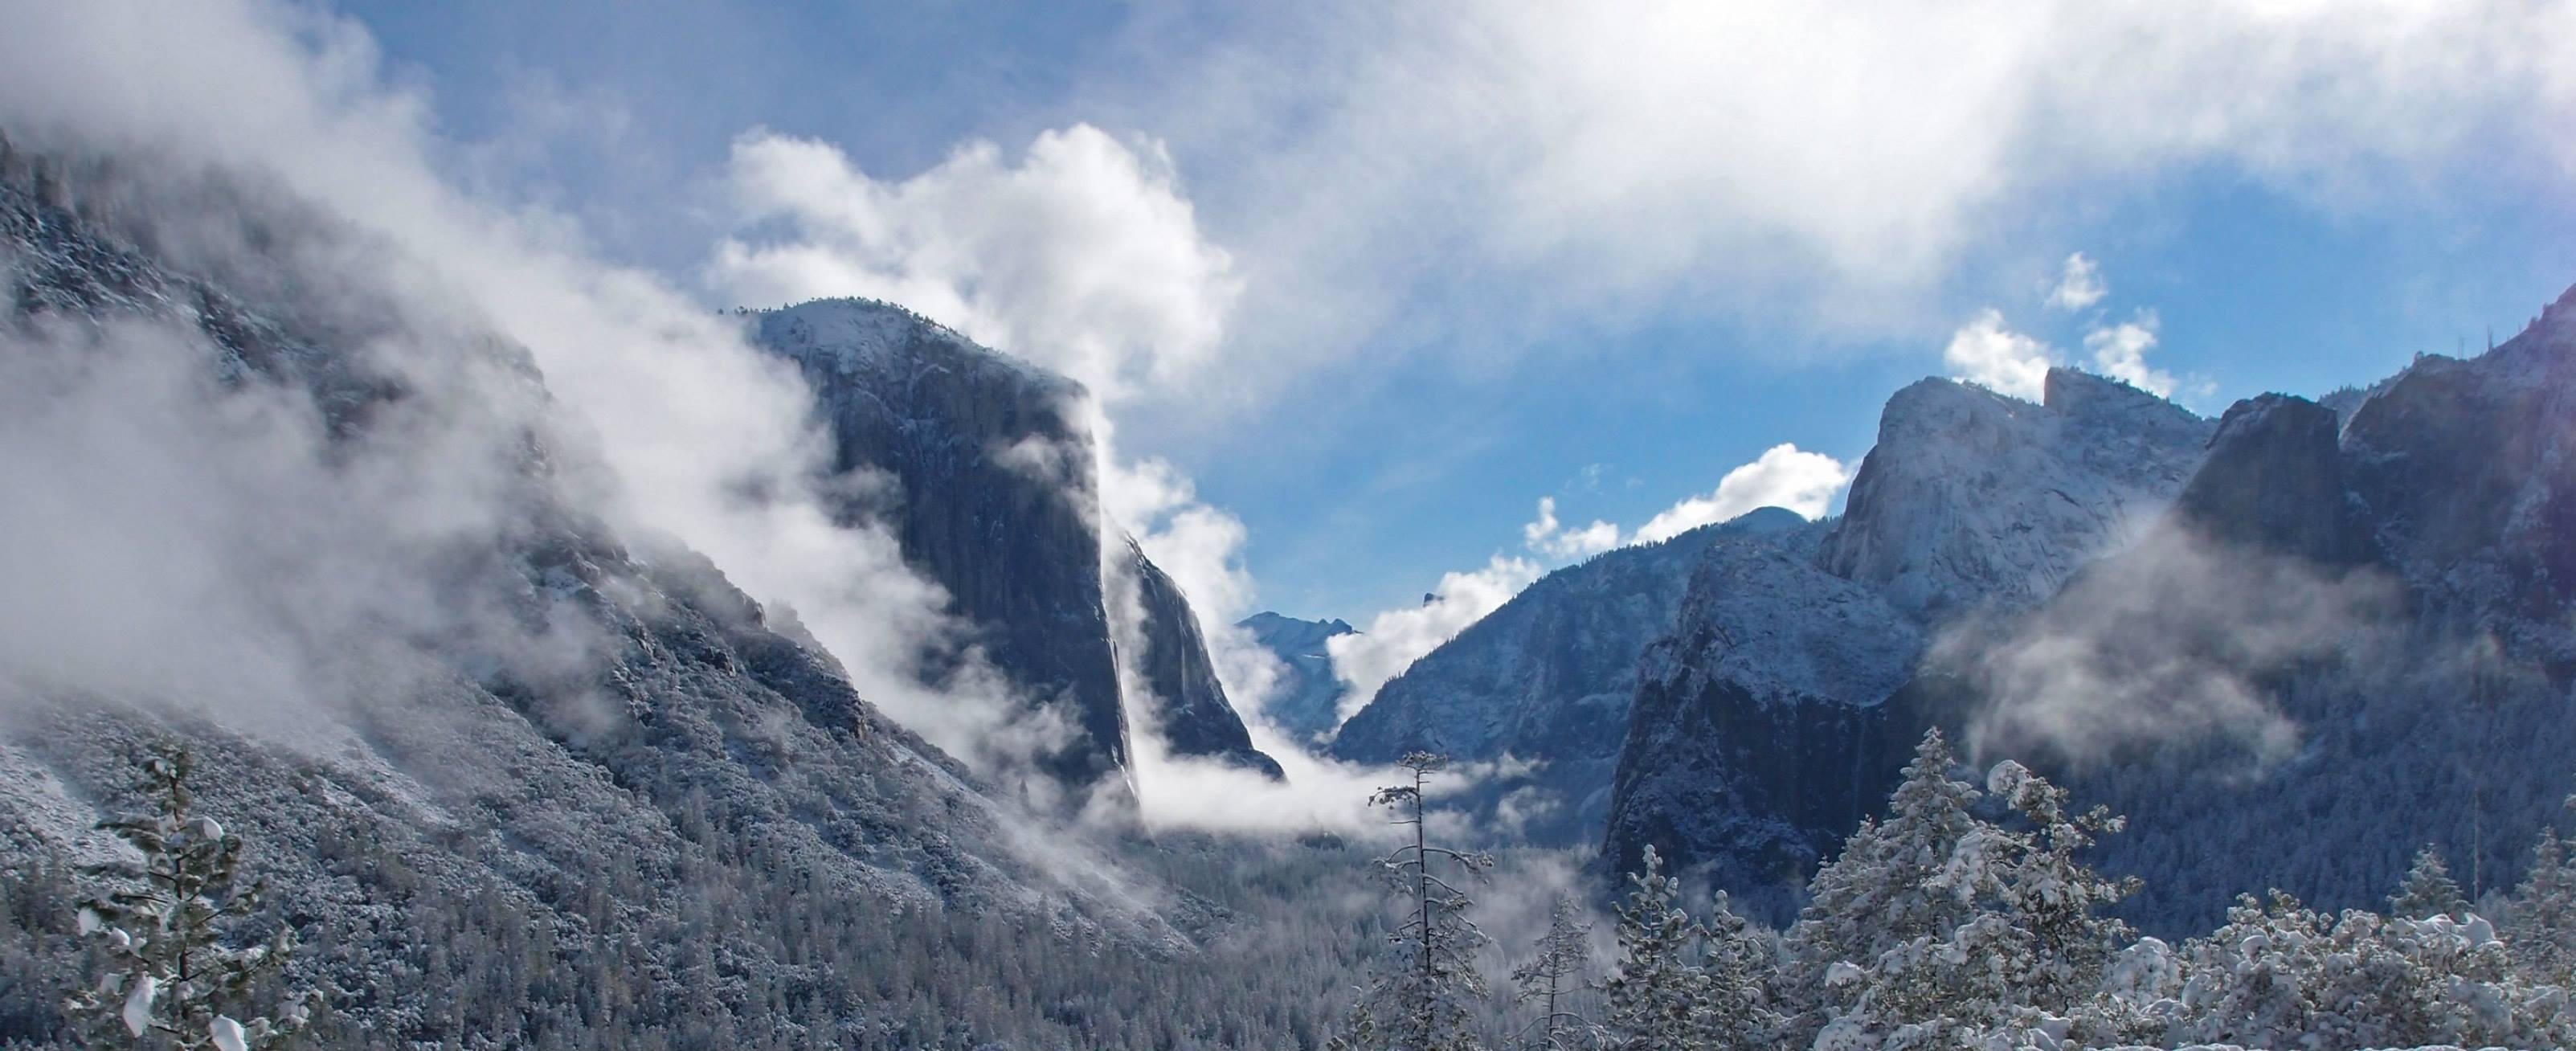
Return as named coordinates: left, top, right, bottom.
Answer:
left=1605, top=368, right=2210, bottom=906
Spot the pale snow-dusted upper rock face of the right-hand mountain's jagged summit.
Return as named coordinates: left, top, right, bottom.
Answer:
left=1822, top=368, right=2210, bottom=621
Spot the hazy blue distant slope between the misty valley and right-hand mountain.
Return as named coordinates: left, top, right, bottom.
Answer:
left=1332, top=508, right=1805, bottom=845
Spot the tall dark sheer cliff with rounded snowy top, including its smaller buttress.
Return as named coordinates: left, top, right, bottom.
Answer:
left=754, top=299, right=1278, bottom=786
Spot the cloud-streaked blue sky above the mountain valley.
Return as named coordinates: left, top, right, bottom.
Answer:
left=348, top=2, right=2576, bottom=624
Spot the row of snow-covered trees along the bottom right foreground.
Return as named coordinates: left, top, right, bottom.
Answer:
left=1332, top=731, right=2576, bottom=1051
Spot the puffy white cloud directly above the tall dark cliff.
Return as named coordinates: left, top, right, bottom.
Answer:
left=709, top=124, right=1241, bottom=402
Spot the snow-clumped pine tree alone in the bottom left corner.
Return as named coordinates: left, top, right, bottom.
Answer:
left=64, top=745, right=320, bottom=1051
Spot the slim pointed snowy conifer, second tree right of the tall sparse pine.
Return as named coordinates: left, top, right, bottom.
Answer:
left=1602, top=845, right=1708, bottom=1051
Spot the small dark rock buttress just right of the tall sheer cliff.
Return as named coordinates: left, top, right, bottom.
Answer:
left=1128, top=543, right=1286, bottom=780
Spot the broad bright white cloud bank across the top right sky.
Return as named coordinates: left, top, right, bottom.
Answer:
left=1110, top=0, right=2576, bottom=368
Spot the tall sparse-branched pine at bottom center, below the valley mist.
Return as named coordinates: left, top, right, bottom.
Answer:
left=1332, top=752, right=1494, bottom=1051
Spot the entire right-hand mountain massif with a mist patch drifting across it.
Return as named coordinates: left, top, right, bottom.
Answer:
left=1605, top=301, right=2576, bottom=930
